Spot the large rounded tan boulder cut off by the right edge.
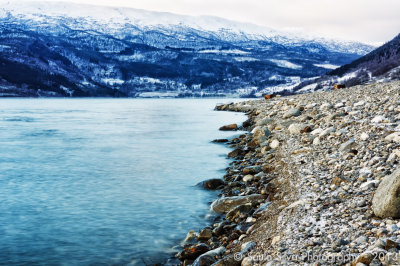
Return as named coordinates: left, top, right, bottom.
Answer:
left=372, top=169, right=400, bottom=218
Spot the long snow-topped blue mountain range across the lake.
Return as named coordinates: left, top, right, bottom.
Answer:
left=0, top=1, right=373, bottom=97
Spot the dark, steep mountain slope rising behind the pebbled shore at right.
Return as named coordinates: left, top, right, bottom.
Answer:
left=294, top=34, right=400, bottom=92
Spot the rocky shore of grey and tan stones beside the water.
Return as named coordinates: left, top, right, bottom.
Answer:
left=173, top=82, right=400, bottom=266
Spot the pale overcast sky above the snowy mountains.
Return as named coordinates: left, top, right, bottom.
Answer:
left=24, top=0, right=400, bottom=44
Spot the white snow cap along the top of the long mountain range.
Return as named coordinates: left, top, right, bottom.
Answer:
left=0, top=0, right=372, bottom=54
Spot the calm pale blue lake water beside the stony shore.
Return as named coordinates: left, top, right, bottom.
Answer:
left=0, top=99, right=245, bottom=265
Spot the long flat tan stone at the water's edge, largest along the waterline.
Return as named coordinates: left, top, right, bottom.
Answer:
left=211, top=194, right=264, bottom=213
